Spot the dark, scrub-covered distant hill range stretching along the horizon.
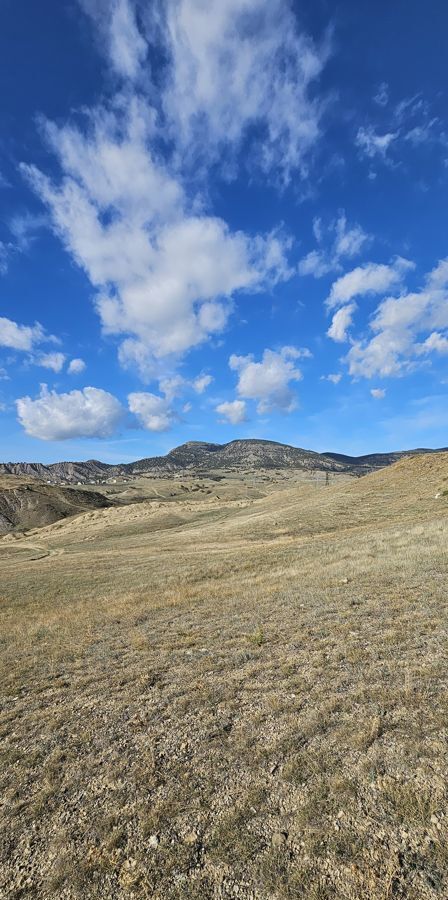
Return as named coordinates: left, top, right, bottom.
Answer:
left=0, top=439, right=444, bottom=484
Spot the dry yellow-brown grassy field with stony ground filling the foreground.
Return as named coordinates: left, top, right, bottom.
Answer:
left=0, top=454, right=448, bottom=900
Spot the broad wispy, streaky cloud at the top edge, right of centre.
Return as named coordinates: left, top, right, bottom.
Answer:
left=155, top=0, right=329, bottom=181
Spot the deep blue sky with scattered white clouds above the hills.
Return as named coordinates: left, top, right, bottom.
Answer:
left=0, top=0, right=448, bottom=462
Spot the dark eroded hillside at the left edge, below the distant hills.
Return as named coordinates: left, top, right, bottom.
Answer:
left=0, top=475, right=111, bottom=534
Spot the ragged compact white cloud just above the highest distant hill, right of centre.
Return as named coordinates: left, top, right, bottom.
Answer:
left=229, top=347, right=302, bottom=414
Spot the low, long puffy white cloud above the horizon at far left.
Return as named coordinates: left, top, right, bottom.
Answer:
left=16, top=385, right=123, bottom=441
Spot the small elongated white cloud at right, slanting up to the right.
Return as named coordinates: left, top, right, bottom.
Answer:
left=326, top=256, right=415, bottom=309
